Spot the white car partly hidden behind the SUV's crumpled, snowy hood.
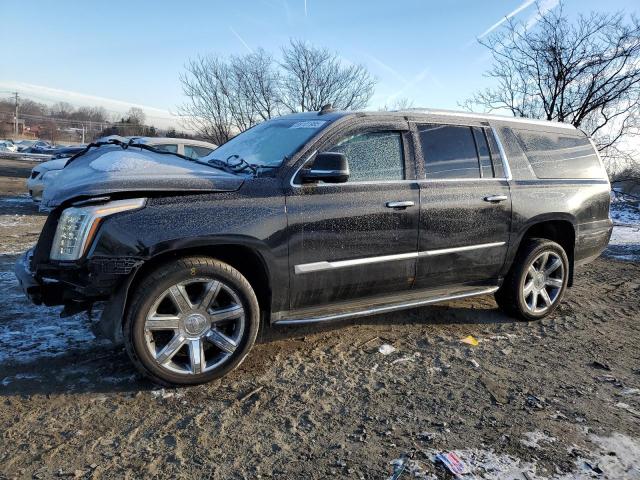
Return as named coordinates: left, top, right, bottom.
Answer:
left=27, top=137, right=218, bottom=203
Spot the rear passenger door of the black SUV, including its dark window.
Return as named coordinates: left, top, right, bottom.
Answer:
left=414, top=123, right=511, bottom=288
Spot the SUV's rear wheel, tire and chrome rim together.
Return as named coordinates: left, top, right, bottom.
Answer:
left=495, top=238, right=569, bottom=321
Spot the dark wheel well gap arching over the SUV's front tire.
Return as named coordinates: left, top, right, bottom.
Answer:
left=127, top=245, right=271, bottom=312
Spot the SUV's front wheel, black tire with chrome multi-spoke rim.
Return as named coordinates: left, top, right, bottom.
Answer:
left=123, top=257, right=260, bottom=386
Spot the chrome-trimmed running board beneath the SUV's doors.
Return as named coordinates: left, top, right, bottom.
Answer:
left=273, top=287, right=499, bottom=325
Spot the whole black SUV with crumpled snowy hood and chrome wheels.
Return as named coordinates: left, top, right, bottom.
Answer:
left=16, top=109, right=612, bottom=385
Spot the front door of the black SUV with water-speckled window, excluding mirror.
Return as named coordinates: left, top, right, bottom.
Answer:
left=286, top=122, right=420, bottom=309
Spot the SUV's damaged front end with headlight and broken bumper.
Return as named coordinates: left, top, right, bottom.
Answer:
left=15, top=198, right=145, bottom=343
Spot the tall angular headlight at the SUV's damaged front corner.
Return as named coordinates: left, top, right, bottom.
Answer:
left=51, top=198, right=146, bottom=260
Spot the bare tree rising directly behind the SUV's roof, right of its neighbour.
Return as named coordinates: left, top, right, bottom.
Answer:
left=281, top=40, right=376, bottom=112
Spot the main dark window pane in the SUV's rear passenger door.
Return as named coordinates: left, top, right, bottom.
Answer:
left=418, top=125, right=480, bottom=178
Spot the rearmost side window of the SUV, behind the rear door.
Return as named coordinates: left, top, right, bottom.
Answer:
left=514, top=129, right=604, bottom=178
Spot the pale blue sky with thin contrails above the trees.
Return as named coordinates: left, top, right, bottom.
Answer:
left=0, top=0, right=640, bottom=128
